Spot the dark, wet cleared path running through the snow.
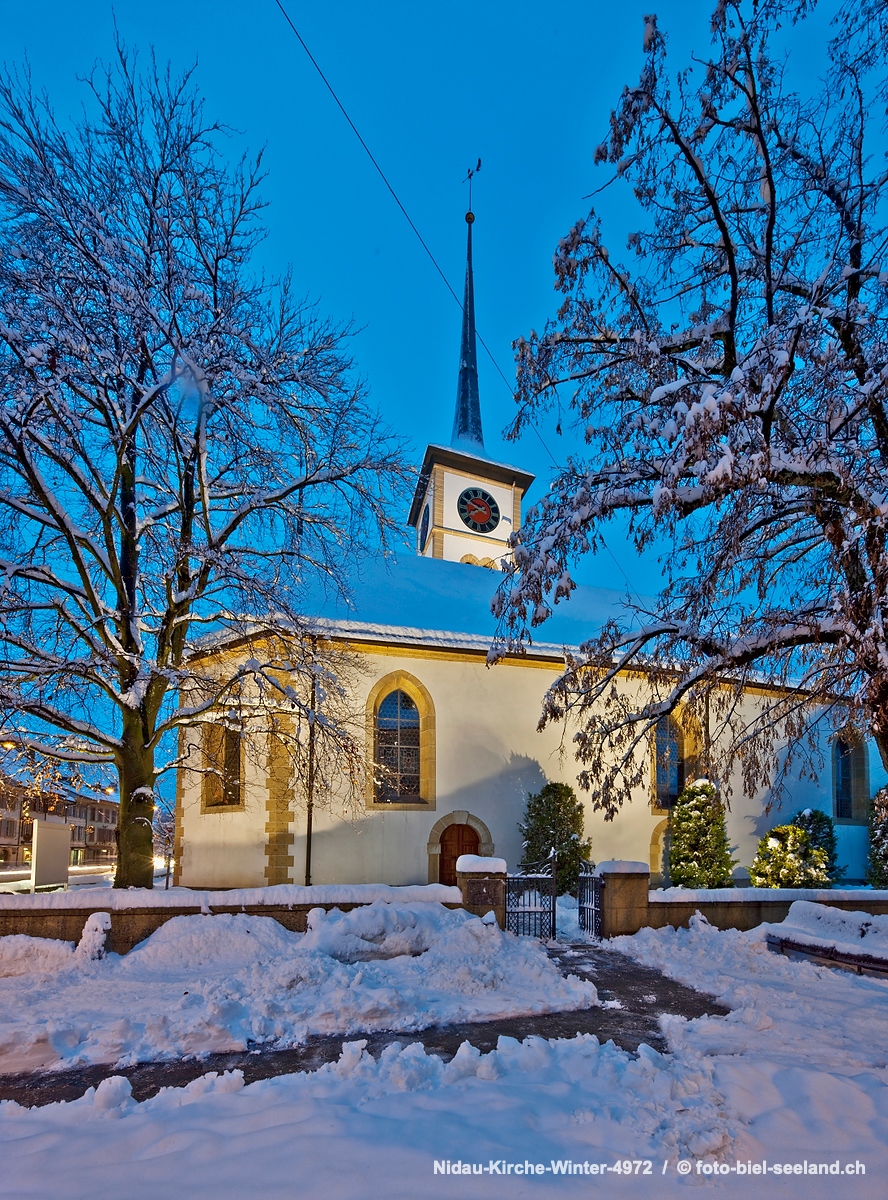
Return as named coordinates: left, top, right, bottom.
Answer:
left=0, top=944, right=728, bottom=1105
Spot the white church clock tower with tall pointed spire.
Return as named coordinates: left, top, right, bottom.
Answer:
left=408, top=212, right=534, bottom=569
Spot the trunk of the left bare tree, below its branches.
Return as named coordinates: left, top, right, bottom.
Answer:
left=114, top=714, right=155, bottom=888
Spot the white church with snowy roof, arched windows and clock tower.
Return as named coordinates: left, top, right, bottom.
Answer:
left=175, top=212, right=883, bottom=888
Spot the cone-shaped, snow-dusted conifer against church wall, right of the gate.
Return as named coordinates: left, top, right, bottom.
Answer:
left=668, top=779, right=736, bottom=888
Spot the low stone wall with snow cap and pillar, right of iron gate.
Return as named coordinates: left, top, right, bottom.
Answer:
left=592, top=863, right=888, bottom=937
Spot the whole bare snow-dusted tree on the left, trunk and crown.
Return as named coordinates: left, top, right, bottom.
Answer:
left=0, top=47, right=407, bottom=887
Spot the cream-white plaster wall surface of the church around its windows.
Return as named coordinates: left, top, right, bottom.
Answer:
left=176, top=648, right=881, bottom=887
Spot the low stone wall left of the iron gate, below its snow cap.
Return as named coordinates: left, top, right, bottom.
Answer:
left=0, top=902, right=460, bottom=954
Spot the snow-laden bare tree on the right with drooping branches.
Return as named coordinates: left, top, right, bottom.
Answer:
left=498, top=0, right=888, bottom=816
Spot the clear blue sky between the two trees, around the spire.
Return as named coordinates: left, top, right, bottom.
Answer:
left=2, top=0, right=830, bottom=592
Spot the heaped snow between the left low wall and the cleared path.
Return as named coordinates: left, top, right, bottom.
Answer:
left=0, top=902, right=596, bottom=1073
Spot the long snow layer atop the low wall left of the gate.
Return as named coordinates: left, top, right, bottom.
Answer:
left=0, top=883, right=462, bottom=912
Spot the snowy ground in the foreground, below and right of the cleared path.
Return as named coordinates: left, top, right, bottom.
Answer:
left=0, top=902, right=888, bottom=1200
